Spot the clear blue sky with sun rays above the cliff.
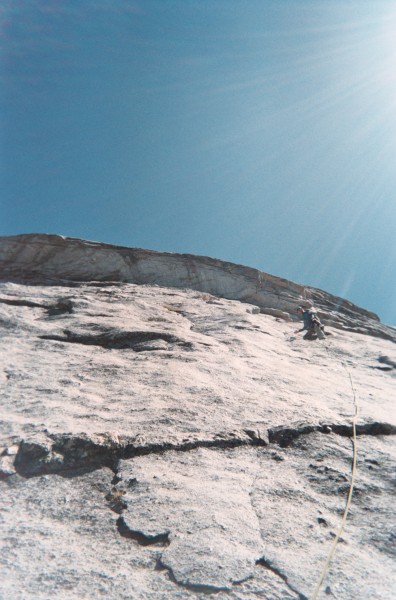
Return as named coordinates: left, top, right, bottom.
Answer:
left=0, top=0, right=396, bottom=325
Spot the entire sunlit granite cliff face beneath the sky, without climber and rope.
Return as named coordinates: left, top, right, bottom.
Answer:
left=0, top=236, right=396, bottom=600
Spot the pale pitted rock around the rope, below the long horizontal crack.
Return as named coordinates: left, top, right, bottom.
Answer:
left=253, top=433, right=396, bottom=599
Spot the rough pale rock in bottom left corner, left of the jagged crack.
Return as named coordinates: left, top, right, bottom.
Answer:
left=0, top=469, right=182, bottom=600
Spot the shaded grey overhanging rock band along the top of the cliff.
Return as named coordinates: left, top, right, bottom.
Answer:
left=0, top=234, right=396, bottom=341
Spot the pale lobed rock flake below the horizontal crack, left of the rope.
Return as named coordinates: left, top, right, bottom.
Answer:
left=117, top=449, right=262, bottom=590
